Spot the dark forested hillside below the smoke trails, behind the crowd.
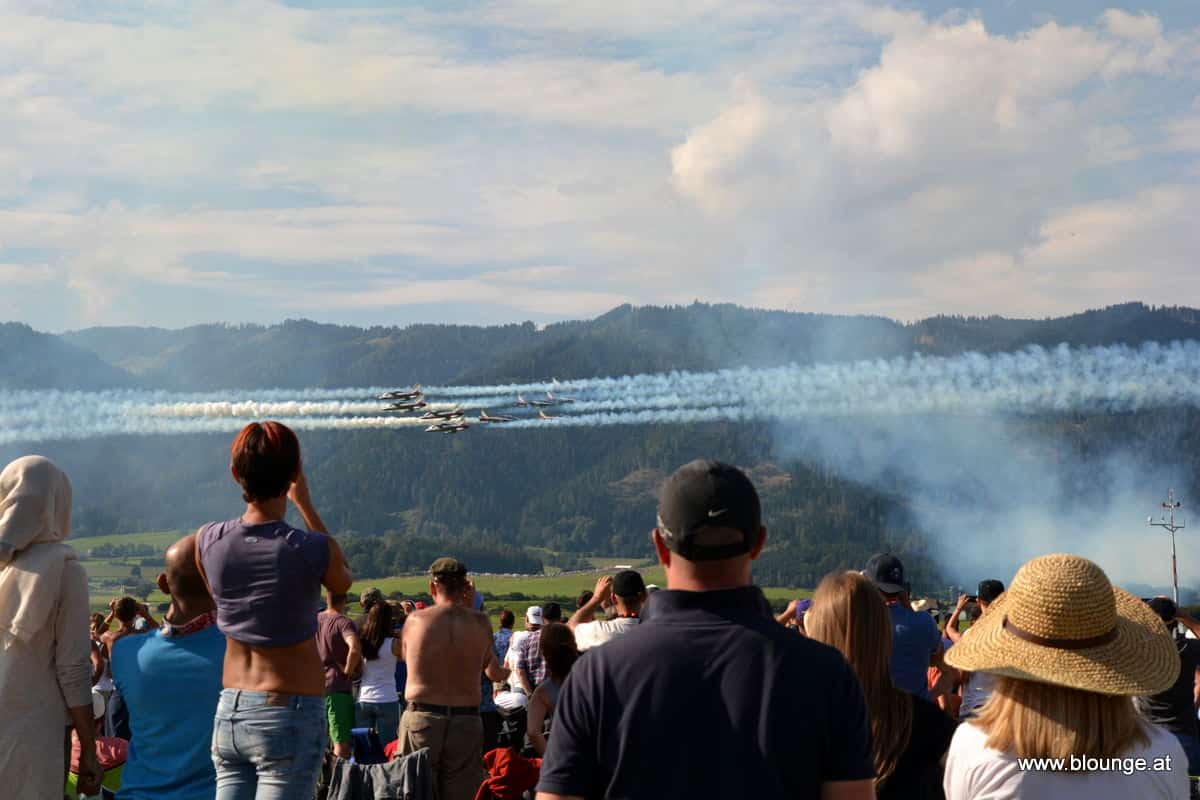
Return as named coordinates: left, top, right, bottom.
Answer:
left=0, top=425, right=936, bottom=585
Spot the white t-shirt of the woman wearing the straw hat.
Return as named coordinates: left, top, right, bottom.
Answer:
left=942, top=722, right=1188, bottom=800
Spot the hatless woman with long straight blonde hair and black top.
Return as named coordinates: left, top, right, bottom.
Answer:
left=804, top=572, right=955, bottom=800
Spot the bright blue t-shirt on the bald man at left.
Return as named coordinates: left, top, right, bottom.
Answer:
left=113, top=625, right=226, bottom=800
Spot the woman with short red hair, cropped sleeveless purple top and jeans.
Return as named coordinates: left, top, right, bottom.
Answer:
left=196, top=422, right=352, bottom=800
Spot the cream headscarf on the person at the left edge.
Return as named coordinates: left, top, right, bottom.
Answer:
left=0, top=456, right=76, bottom=649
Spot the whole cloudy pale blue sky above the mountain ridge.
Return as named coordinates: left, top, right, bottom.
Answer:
left=0, top=0, right=1200, bottom=331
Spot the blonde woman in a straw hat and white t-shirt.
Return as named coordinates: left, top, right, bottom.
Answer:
left=946, top=554, right=1188, bottom=800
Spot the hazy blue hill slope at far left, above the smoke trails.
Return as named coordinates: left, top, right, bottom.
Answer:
left=0, top=323, right=137, bottom=389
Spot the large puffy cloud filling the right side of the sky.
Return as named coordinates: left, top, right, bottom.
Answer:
left=673, top=11, right=1200, bottom=317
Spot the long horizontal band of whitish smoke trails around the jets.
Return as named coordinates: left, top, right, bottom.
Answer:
left=0, top=342, right=1200, bottom=443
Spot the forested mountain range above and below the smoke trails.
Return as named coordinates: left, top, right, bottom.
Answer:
left=0, top=303, right=1200, bottom=588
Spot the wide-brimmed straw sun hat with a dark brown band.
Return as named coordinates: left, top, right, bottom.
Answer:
left=946, top=554, right=1180, bottom=696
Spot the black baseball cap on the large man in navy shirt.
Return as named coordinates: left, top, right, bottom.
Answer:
left=658, top=459, right=762, bottom=561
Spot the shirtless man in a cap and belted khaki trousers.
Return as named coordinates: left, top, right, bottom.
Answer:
left=396, top=558, right=509, bottom=800
